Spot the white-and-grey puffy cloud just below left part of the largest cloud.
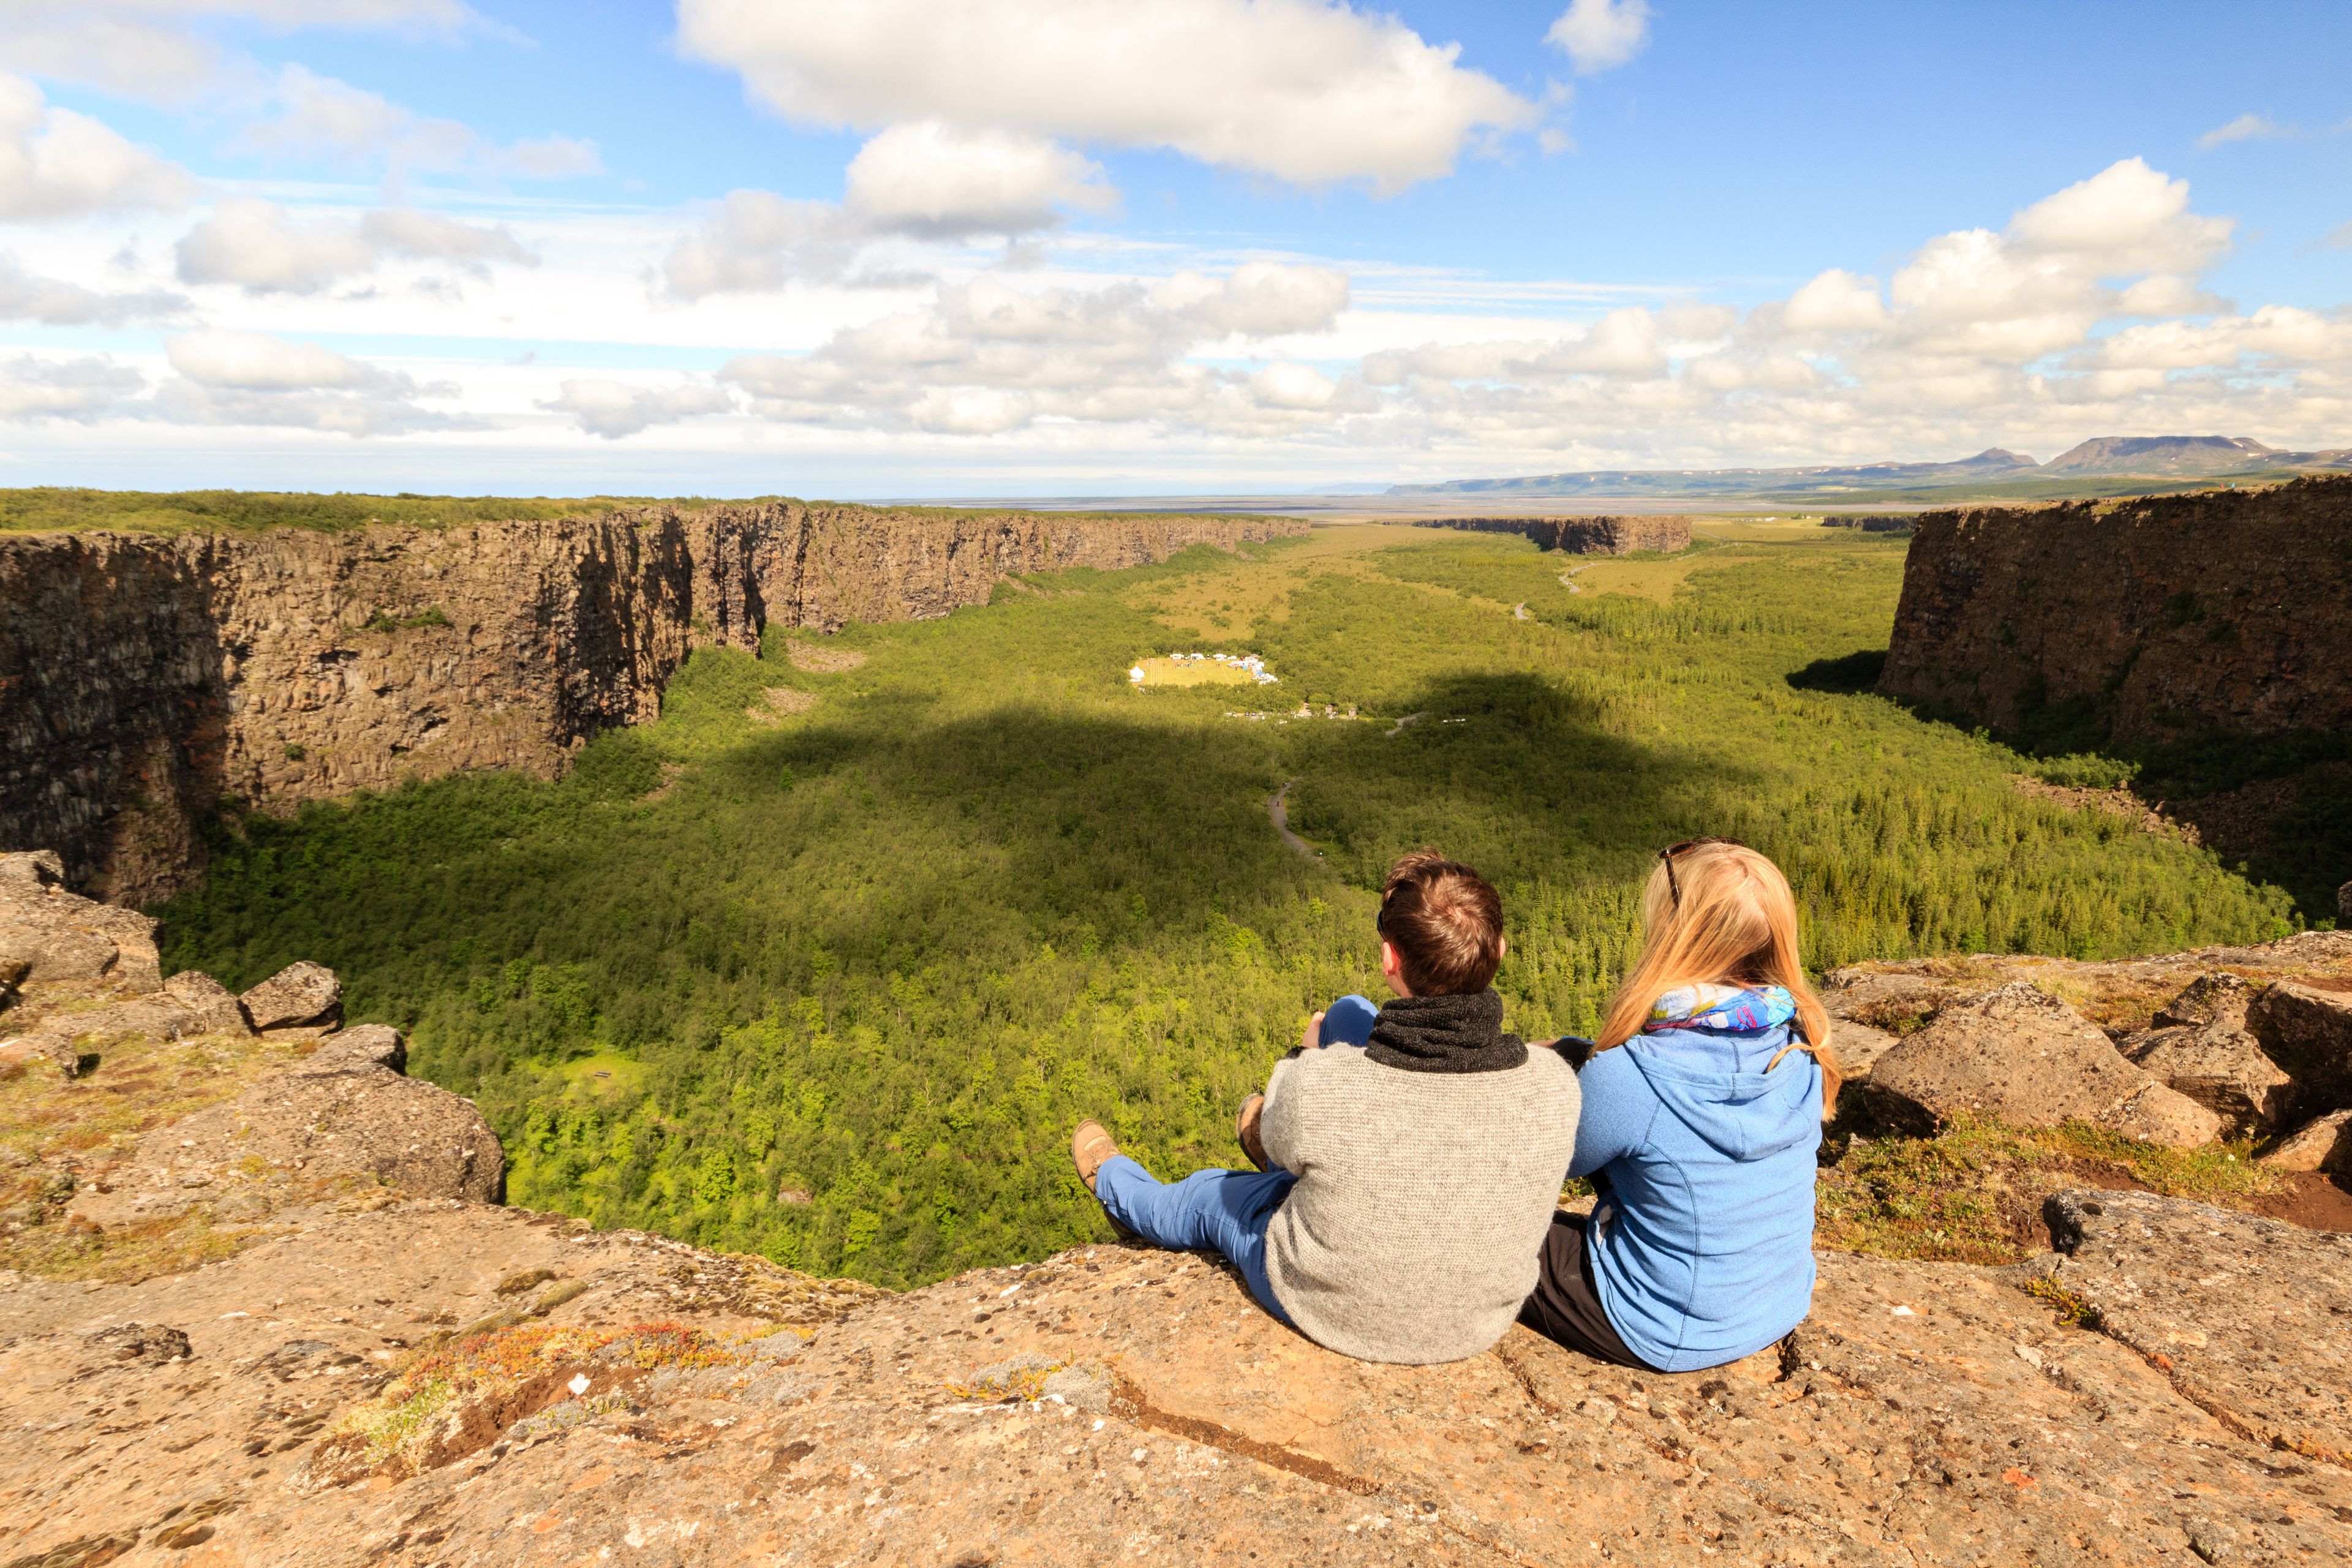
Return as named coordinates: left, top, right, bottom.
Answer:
left=663, top=120, right=1120, bottom=298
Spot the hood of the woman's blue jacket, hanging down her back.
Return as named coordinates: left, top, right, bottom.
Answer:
left=1618, top=1025, right=1820, bottom=1161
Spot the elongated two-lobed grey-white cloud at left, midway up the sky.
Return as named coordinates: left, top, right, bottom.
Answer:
left=176, top=197, right=538, bottom=294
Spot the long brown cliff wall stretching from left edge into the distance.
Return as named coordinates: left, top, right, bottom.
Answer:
left=0, top=501, right=1305, bottom=903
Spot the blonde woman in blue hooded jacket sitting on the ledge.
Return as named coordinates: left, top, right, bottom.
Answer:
left=1520, top=839, right=1837, bottom=1373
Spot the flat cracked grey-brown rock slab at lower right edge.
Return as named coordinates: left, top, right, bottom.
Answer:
left=2022, top=1192, right=2352, bottom=1476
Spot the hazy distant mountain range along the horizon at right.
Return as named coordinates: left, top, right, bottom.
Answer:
left=1388, top=435, right=2352, bottom=501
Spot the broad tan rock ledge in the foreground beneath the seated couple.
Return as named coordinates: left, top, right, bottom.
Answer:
left=0, top=1194, right=2352, bottom=1568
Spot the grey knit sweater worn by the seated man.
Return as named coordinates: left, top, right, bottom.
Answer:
left=1261, top=1030, right=1578, bottom=1363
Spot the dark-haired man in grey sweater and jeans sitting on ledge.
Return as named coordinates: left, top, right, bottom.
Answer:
left=1070, top=849, right=1578, bottom=1363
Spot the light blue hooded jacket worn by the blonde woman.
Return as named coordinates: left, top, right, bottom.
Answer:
left=1569, top=1006, right=1820, bottom=1373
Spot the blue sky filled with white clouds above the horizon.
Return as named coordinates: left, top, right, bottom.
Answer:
left=0, top=0, right=2352, bottom=496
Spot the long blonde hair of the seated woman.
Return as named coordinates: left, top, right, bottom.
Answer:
left=1595, top=839, right=1842, bottom=1114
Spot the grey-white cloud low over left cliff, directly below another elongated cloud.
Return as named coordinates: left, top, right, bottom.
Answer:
left=153, top=329, right=482, bottom=437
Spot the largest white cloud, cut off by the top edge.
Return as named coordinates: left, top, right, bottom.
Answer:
left=677, top=0, right=1540, bottom=193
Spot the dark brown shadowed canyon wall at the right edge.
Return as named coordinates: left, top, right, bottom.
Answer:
left=1879, top=477, right=2352, bottom=741
